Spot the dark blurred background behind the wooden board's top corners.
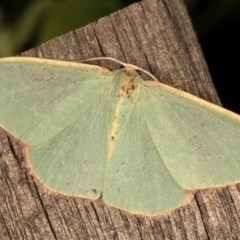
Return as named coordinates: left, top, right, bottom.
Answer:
left=0, top=0, right=240, bottom=114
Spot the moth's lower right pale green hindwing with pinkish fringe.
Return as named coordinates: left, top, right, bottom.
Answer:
left=103, top=86, right=191, bottom=215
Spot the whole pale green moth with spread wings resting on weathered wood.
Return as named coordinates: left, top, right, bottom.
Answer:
left=0, top=57, right=240, bottom=216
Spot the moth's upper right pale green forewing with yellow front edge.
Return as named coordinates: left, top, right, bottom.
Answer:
left=141, top=82, right=240, bottom=189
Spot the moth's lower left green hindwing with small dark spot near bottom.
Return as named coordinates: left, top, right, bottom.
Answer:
left=27, top=88, right=114, bottom=199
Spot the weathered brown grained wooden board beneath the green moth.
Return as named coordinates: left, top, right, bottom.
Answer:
left=0, top=0, right=240, bottom=240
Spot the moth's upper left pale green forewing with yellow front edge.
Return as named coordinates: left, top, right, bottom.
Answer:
left=0, top=57, right=112, bottom=145
